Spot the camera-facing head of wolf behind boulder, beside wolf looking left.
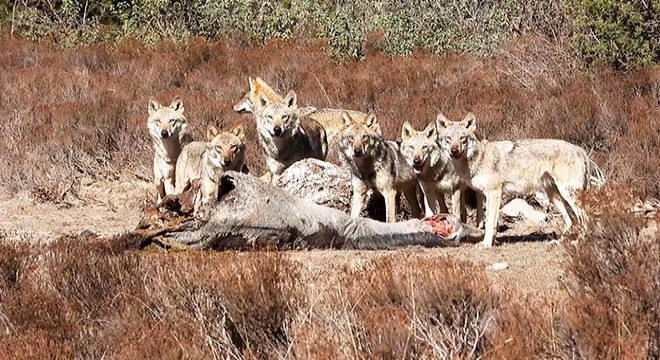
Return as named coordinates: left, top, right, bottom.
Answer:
left=255, top=90, right=300, bottom=139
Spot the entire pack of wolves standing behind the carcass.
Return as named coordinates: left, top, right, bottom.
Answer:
left=147, top=77, right=604, bottom=247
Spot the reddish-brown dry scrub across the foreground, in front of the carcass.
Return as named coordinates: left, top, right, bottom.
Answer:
left=0, top=202, right=660, bottom=359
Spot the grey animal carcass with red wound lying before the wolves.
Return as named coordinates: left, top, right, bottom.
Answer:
left=133, top=171, right=483, bottom=250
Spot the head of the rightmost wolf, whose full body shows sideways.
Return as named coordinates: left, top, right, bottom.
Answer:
left=435, top=113, right=479, bottom=160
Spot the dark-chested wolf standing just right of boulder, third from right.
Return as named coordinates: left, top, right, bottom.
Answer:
left=337, top=112, right=421, bottom=222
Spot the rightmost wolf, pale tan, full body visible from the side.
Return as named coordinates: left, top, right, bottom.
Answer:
left=436, top=113, right=593, bottom=247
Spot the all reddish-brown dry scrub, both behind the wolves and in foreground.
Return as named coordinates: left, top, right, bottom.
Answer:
left=0, top=32, right=660, bottom=359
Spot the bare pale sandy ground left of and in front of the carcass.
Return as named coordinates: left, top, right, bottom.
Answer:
left=0, top=181, right=565, bottom=298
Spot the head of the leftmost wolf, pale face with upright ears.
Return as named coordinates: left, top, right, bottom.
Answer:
left=147, top=97, right=188, bottom=139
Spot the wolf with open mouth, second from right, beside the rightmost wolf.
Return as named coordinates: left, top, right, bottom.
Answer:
left=400, top=121, right=467, bottom=222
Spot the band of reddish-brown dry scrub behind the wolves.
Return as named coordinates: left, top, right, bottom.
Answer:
left=0, top=38, right=660, bottom=201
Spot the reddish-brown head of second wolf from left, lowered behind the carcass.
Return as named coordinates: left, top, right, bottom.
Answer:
left=206, top=125, right=245, bottom=171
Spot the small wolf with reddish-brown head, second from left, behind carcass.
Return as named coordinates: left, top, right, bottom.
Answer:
left=174, top=124, right=248, bottom=194
